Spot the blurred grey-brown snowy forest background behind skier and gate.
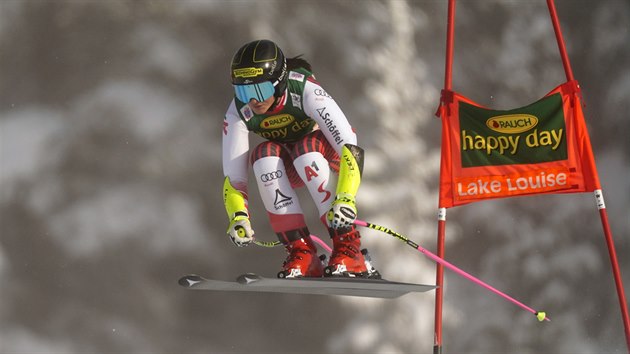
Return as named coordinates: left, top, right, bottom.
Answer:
left=0, top=0, right=630, bottom=353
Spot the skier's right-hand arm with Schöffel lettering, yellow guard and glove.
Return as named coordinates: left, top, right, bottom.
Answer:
left=302, top=81, right=363, bottom=229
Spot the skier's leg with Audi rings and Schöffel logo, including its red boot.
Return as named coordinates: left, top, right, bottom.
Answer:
left=252, top=142, right=322, bottom=277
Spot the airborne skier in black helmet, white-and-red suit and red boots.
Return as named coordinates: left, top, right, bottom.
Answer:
left=223, top=40, right=378, bottom=278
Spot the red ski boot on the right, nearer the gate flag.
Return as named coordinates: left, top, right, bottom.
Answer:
left=324, top=227, right=380, bottom=278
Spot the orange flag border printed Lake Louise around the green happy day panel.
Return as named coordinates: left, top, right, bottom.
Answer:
left=439, top=80, right=601, bottom=208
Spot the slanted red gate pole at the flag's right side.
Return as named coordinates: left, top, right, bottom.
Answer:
left=547, top=0, right=630, bottom=353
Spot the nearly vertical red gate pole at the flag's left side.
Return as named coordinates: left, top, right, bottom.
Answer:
left=433, top=0, right=455, bottom=354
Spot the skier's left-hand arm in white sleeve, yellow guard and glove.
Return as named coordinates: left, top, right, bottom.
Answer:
left=223, top=101, right=254, bottom=247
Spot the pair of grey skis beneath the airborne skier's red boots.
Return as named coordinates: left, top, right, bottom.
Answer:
left=179, top=273, right=436, bottom=299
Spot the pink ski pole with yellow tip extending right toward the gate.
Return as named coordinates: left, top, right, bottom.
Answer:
left=354, top=220, right=551, bottom=322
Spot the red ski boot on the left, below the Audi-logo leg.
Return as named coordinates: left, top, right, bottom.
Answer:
left=278, top=236, right=323, bottom=278
